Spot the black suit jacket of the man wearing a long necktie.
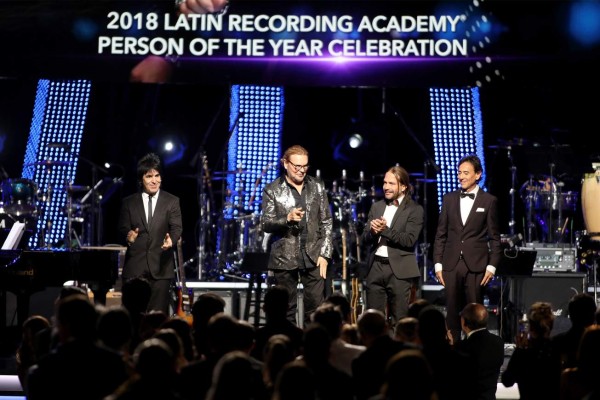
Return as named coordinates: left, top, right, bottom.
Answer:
left=119, top=190, right=182, bottom=279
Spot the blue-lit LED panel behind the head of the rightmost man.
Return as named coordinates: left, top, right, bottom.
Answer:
left=429, top=88, right=486, bottom=208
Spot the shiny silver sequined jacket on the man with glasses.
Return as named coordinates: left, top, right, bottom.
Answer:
left=261, top=175, right=333, bottom=270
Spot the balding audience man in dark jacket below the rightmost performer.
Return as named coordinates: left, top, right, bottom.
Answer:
left=455, top=303, right=504, bottom=400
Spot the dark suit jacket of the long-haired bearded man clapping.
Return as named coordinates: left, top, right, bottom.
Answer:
left=363, top=196, right=423, bottom=279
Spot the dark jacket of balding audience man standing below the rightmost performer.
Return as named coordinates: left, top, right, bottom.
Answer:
left=455, top=329, right=504, bottom=400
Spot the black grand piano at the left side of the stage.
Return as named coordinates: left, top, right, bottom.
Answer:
left=0, top=247, right=121, bottom=327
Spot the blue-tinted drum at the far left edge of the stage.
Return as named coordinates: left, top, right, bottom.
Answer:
left=2, top=179, right=38, bottom=217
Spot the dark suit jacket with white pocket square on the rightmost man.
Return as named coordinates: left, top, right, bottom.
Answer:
left=433, top=188, right=502, bottom=272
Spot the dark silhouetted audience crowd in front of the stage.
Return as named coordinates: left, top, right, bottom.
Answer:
left=21, top=279, right=600, bottom=400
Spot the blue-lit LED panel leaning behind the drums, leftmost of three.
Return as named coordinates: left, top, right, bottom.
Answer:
left=22, top=80, right=91, bottom=248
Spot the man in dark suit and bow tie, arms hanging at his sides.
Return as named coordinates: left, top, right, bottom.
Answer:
left=433, top=155, right=502, bottom=342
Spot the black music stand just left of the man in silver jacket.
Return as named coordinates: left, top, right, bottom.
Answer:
left=240, top=252, right=270, bottom=328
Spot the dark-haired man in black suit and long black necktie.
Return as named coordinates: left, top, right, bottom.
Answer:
left=118, top=153, right=182, bottom=315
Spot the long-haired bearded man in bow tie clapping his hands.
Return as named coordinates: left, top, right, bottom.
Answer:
left=363, top=166, right=423, bottom=325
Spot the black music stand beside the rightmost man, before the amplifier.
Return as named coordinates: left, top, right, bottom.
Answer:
left=496, top=247, right=537, bottom=342
